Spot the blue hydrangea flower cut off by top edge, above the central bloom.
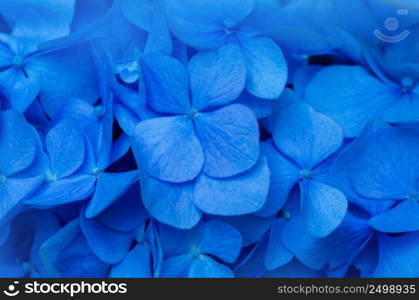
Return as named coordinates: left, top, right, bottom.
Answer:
left=165, top=0, right=287, bottom=99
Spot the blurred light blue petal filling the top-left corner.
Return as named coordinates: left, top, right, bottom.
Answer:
left=0, top=0, right=76, bottom=41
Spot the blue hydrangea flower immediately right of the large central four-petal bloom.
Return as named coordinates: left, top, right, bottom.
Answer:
left=259, top=103, right=347, bottom=237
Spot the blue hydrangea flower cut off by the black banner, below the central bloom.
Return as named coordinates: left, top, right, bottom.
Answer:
left=159, top=221, right=242, bottom=277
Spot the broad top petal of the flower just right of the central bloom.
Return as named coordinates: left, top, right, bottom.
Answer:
left=273, top=103, right=343, bottom=170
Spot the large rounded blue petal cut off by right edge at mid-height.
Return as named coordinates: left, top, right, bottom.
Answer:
left=349, top=128, right=419, bottom=200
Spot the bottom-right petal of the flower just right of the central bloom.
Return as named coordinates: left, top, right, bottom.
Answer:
left=300, top=180, right=348, bottom=237
